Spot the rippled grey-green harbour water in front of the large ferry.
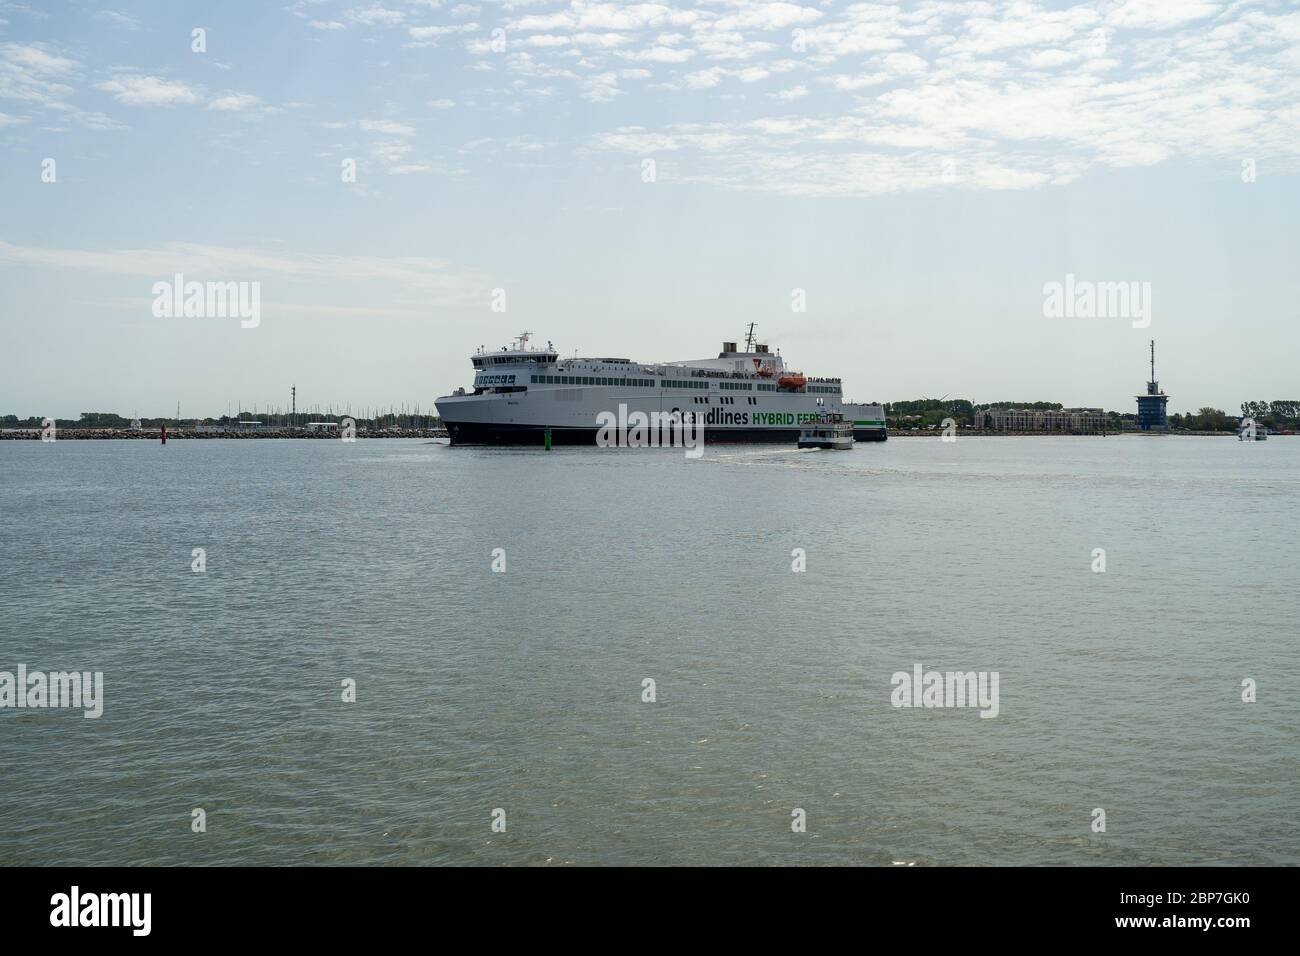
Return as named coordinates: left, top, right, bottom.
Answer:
left=0, top=437, right=1300, bottom=865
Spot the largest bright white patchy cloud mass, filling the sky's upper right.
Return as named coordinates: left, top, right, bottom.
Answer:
left=559, top=0, right=1300, bottom=196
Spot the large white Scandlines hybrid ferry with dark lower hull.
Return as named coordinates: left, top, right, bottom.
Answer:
left=436, top=324, right=888, bottom=445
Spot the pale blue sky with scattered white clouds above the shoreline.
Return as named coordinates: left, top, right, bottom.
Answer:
left=0, top=0, right=1300, bottom=418
